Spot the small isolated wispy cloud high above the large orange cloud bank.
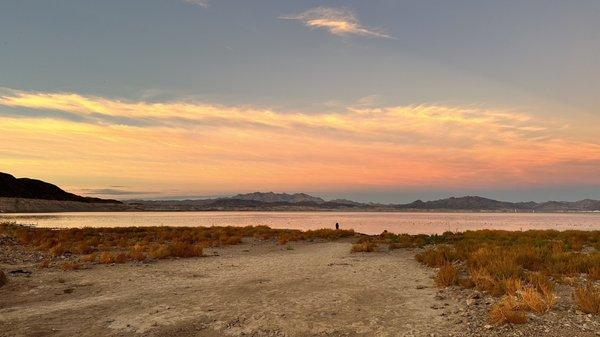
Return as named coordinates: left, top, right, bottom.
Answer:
left=279, top=7, right=393, bottom=39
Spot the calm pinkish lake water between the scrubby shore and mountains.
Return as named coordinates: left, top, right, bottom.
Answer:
left=0, top=212, right=600, bottom=234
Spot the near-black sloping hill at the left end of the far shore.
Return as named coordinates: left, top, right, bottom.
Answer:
left=0, top=172, right=121, bottom=204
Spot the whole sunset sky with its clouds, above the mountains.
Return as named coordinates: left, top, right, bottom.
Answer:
left=0, top=0, right=600, bottom=202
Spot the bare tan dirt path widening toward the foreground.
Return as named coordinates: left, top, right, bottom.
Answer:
left=0, top=242, right=458, bottom=336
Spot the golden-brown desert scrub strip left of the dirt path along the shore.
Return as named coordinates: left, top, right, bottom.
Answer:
left=0, top=223, right=356, bottom=270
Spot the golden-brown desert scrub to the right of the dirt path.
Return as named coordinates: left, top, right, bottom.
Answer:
left=353, top=230, right=600, bottom=324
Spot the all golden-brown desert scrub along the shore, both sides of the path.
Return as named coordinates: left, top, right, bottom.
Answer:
left=0, top=223, right=600, bottom=324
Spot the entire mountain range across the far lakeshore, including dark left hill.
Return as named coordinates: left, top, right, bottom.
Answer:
left=0, top=172, right=600, bottom=212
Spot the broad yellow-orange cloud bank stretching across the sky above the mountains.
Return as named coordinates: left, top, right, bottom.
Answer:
left=0, top=91, right=600, bottom=195
